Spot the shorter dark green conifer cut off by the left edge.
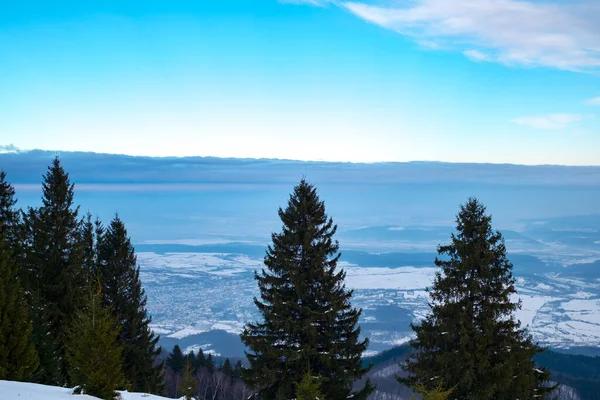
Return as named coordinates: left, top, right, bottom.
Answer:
left=0, top=227, right=39, bottom=381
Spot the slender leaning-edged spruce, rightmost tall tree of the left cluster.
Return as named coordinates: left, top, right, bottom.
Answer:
left=98, top=216, right=164, bottom=393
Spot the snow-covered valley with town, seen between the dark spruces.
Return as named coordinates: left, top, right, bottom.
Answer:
left=137, top=222, right=600, bottom=357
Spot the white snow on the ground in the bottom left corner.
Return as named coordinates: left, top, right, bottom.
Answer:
left=0, top=380, right=173, bottom=400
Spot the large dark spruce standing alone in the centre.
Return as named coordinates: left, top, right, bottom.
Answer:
left=241, top=179, right=373, bottom=400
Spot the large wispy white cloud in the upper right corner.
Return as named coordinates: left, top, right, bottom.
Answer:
left=338, top=0, right=600, bottom=72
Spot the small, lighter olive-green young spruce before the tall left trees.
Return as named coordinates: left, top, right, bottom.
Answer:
left=67, top=293, right=125, bottom=400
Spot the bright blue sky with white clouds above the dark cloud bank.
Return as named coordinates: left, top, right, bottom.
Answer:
left=0, top=0, right=600, bottom=165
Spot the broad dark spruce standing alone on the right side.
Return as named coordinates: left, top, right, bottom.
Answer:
left=399, top=198, right=552, bottom=400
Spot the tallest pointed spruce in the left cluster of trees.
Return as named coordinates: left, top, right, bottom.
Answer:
left=22, top=157, right=86, bottom=385
